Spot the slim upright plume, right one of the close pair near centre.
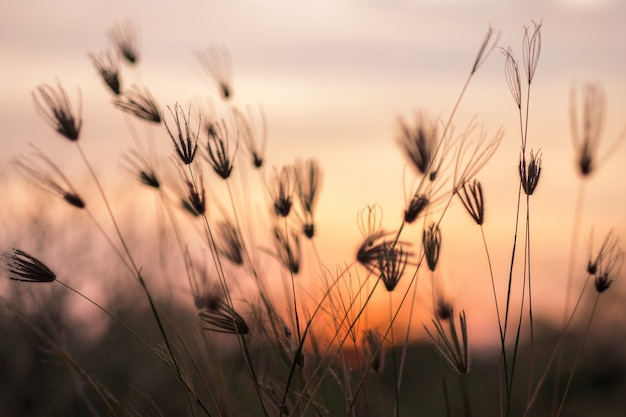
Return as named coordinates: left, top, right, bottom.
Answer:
left=295, top=159, right=322, bottom=239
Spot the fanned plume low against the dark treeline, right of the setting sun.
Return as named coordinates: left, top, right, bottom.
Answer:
left=424, top=311, right=470, bottom=375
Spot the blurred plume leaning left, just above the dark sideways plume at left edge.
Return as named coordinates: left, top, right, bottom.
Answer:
left=12, top=146, right=85, bottom=209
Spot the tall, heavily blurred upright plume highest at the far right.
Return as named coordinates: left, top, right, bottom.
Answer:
left=570, top=83, right=606, bottom=177
